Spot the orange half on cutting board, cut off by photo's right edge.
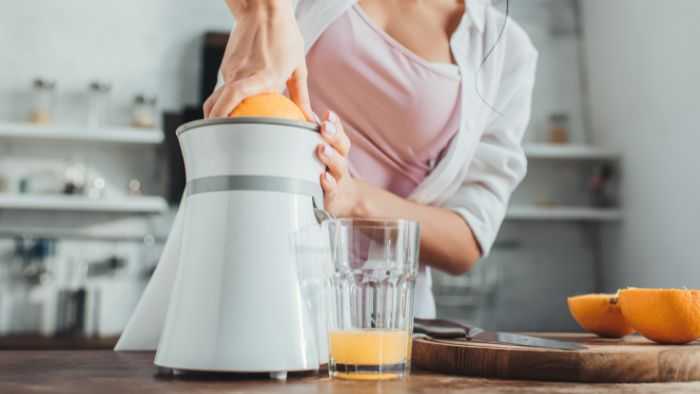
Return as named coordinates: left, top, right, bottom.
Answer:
left=619, top=288, right=700, bottom=344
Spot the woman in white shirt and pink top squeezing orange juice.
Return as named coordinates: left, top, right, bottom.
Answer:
left=204, top=0, right=537, bottom=317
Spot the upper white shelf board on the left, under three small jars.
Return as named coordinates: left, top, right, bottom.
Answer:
left=0, top=122, right=163, bottom=144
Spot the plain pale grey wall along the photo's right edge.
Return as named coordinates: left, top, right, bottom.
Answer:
left=581, top=0, right=700, bottom=290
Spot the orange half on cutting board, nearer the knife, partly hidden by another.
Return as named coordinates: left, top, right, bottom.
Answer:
left=567, top=294, right=634, bottom=338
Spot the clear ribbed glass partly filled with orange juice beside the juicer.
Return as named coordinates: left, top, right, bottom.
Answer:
left=327, top=219, right=419, bottom=380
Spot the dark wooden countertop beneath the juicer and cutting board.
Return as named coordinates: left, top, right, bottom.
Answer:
left=0, top=350, right=700, bottom=394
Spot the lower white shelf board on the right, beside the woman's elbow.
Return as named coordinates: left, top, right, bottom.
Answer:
left=506, top=205, right=622, bottom=222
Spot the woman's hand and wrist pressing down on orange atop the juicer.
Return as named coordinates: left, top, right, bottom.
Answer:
left=203, top=0, right=313, bottom=120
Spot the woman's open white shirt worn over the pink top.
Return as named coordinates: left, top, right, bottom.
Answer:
left=296, top=0, right=537, bottom=317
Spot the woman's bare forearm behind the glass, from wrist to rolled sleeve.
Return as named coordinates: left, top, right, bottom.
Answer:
left=353, top=181, right=481, bottom=275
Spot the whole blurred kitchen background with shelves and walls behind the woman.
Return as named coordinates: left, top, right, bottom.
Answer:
left=0, top=0, right=700, bottom=348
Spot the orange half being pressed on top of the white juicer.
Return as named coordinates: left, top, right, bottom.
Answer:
left=229, top=93, right=306, bottom=121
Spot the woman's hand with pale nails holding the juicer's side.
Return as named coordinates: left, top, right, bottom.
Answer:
left=316, top=111, right=362, bottom=217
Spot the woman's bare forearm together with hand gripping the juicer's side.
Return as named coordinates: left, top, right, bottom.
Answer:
left=317, top=113, right=481, bottom=274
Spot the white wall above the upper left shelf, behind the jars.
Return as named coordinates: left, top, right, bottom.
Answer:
left=0, top=0, right=232, bottom=123
